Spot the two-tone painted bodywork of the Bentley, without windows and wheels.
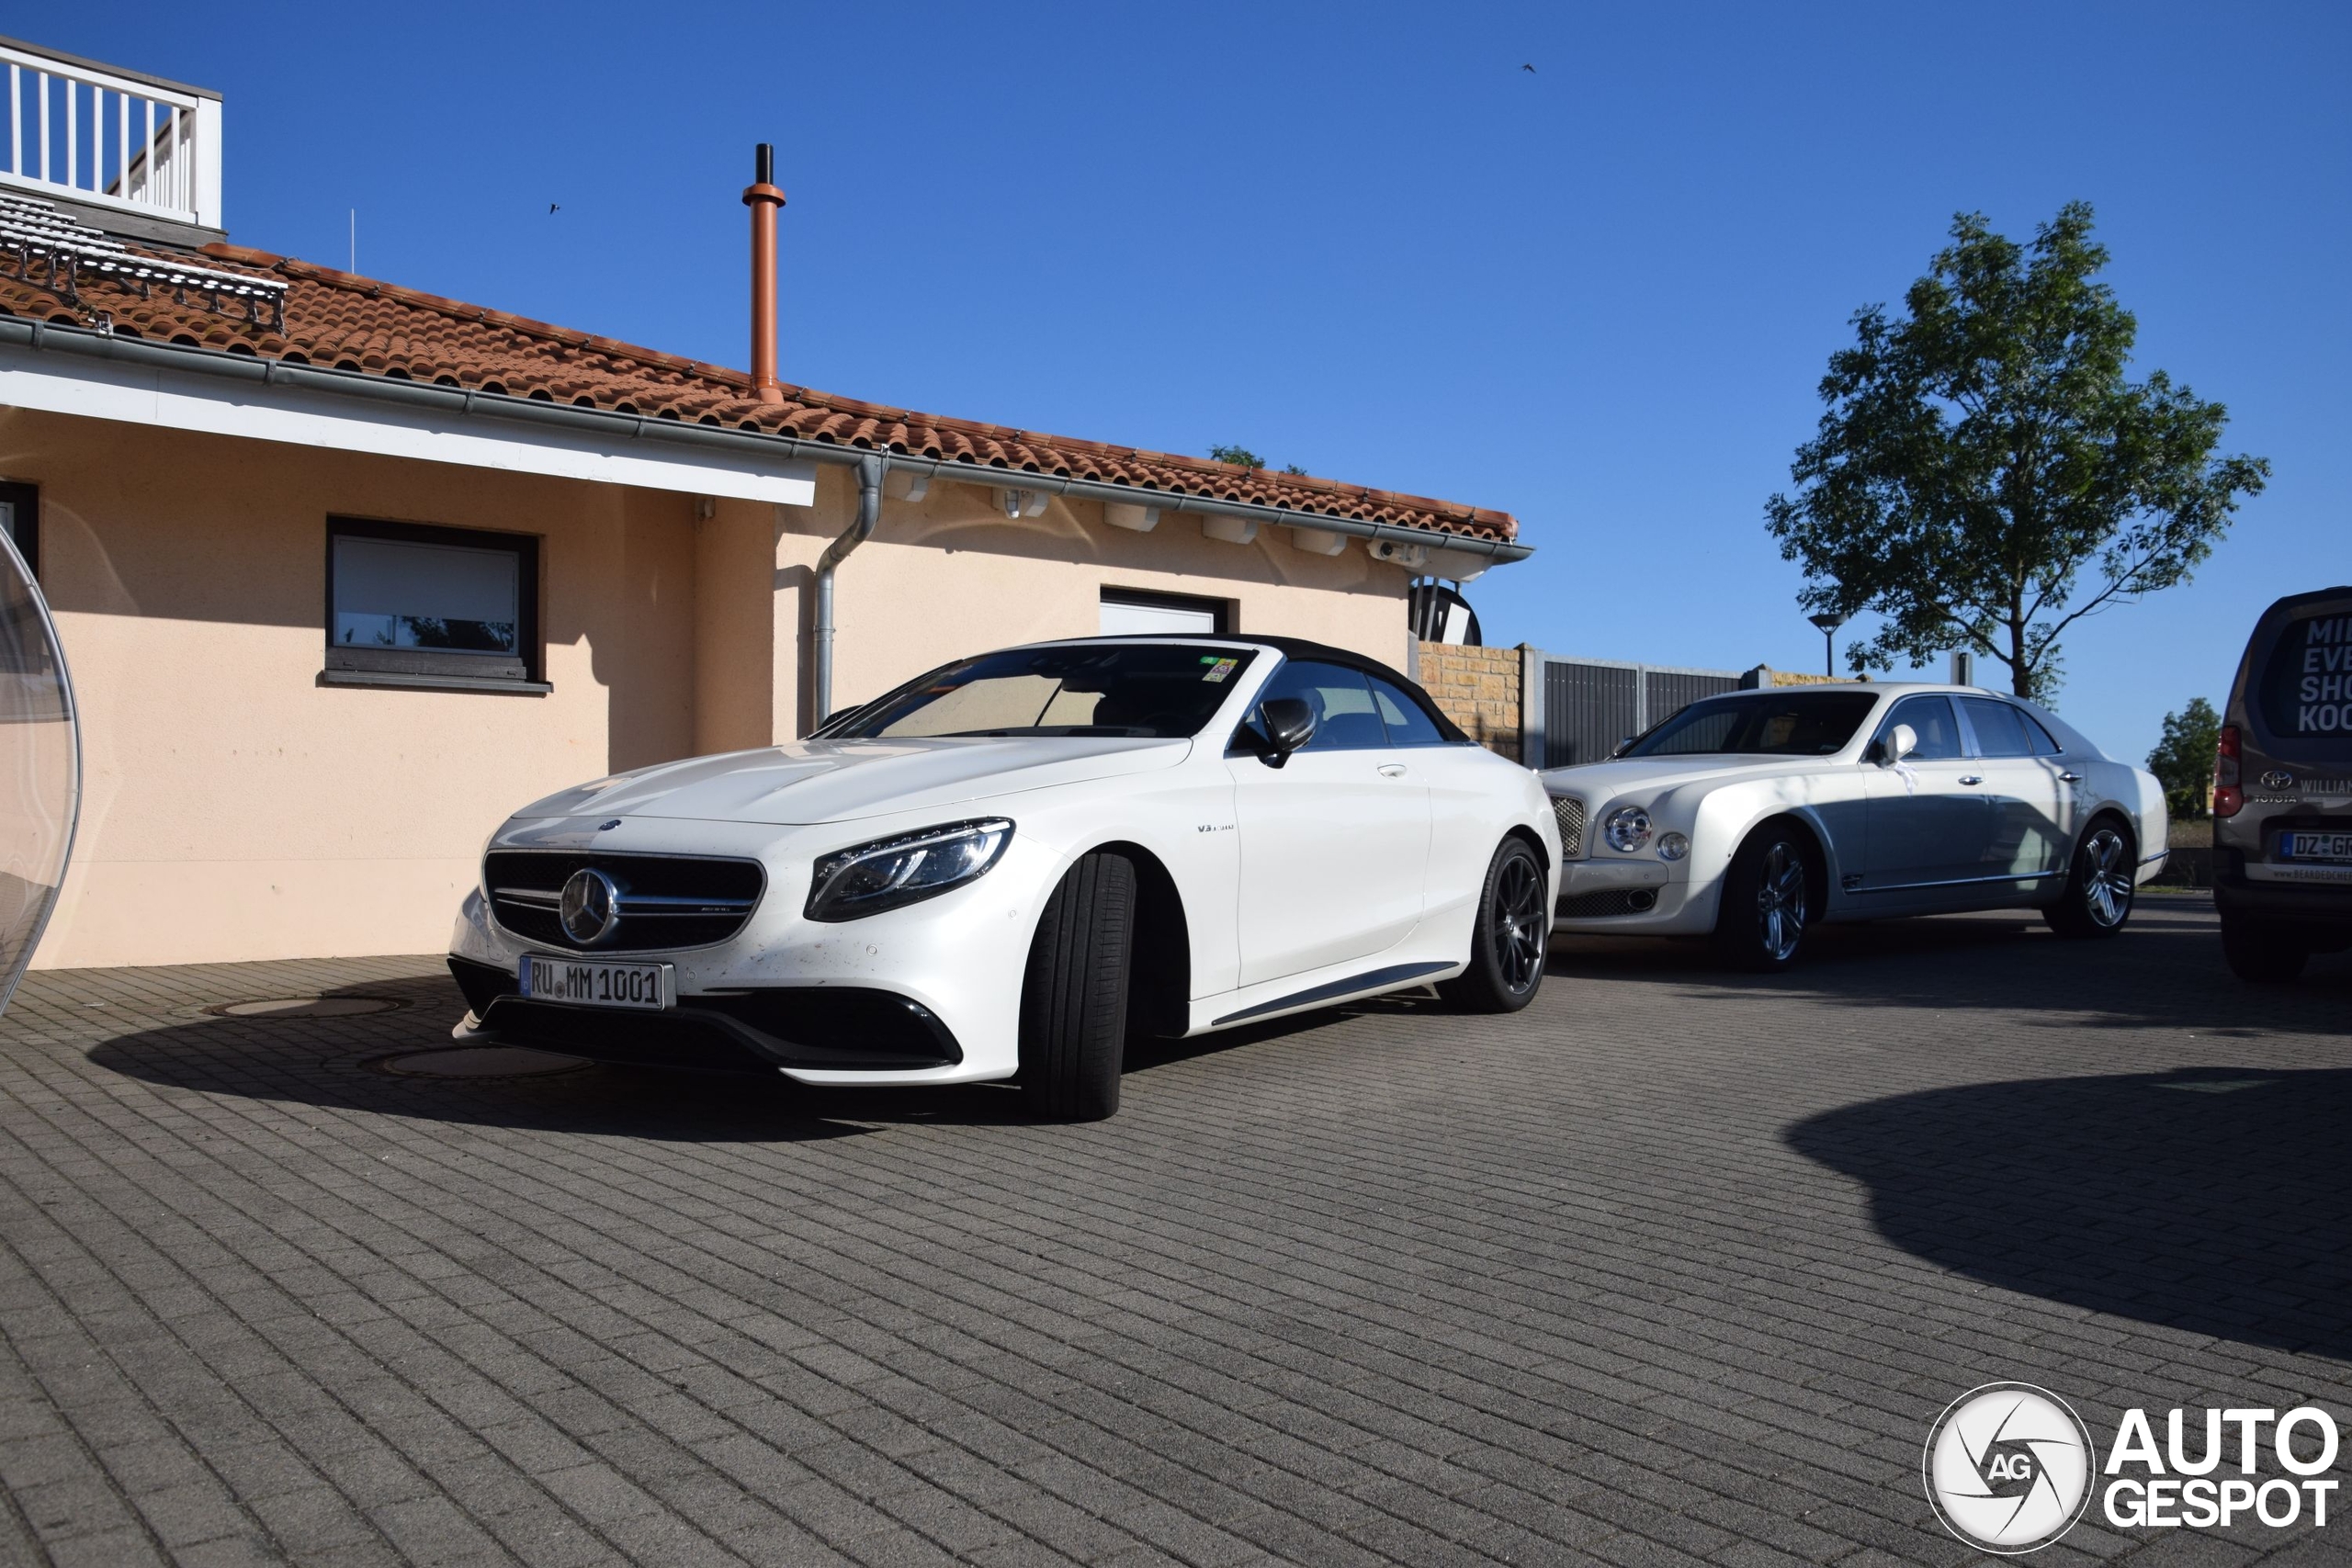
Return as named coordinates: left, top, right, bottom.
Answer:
left=1543, top=684, right=2168, bottom=936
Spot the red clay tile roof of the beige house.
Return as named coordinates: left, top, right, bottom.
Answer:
left=0, top=244, right=1520, bottom=541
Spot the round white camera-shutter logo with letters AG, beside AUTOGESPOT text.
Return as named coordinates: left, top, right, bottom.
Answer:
left=1922, top=1382, right=2091, bottom=1556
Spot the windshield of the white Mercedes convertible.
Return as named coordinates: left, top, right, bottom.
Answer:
left=826, top=642, right=1251, bottom=740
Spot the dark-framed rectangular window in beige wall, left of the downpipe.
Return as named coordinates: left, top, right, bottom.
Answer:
left=327, top=517, right=538, bottom=684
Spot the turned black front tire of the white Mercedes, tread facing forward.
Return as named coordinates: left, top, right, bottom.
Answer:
left=1021, top=853, right=1136, bottom=1122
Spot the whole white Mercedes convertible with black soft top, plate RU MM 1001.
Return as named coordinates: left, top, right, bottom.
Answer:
left=449, top=637, right=1559, bottom=1119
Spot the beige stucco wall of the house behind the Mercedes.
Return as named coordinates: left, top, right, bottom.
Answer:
left=0, top=409, right=1407, bottom=966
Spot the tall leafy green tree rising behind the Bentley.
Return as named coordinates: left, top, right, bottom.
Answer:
left=1764, top=202, right=2269, bottom=698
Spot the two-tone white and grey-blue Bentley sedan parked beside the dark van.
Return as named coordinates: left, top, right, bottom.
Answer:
left=1543, top=684, right=2166, bottom=968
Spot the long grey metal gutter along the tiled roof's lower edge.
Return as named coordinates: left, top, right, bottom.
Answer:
left=0, top=315, right=1536, bottom=564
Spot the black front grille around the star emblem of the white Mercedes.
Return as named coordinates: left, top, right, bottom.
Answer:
left=482, top=849, right=767, bottom=952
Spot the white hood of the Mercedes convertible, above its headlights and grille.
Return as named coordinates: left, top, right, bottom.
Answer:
left=515, top=736, right=1193, bottom=825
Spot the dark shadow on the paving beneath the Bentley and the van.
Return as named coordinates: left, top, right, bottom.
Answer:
left=1550, top=900, right=2352, bottom=1039
